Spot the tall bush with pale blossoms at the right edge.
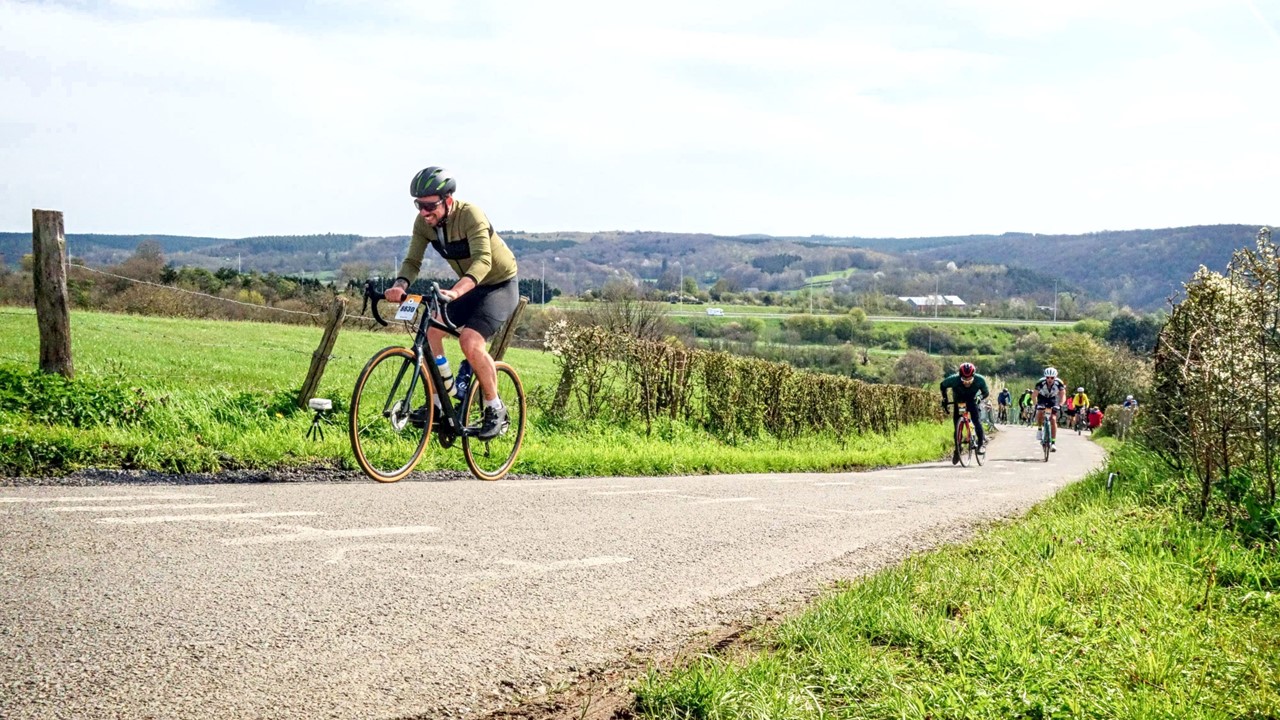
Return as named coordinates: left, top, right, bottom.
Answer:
left=1143, top=228, right=1280, bottom=539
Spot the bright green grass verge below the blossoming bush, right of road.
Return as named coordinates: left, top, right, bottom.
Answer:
left=635, top=446, right=1280, bottom=720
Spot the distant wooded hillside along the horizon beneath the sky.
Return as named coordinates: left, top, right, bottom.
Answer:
left=0, top=224, right=1258, bottom=310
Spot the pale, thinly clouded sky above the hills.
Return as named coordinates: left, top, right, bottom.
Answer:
left=0, top=0, right=1280, bottom=237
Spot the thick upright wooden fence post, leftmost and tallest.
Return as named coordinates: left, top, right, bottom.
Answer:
left=31, top=210, right=76, bottom=378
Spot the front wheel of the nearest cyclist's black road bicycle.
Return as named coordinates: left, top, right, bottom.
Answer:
left=349, top=346, right=435, bottom=483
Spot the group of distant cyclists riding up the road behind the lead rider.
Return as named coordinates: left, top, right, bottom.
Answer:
left=938, top=363, right=1138, bottom=465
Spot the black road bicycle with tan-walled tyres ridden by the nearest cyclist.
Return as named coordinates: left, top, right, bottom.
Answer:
left=349, top=283, right=525, bottom=483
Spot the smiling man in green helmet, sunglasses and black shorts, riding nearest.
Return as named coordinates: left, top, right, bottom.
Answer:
left=385, top=165, right=520, bottom=439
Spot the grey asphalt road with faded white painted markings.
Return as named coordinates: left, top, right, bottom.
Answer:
left=0, top=428, right=1103, bottom=719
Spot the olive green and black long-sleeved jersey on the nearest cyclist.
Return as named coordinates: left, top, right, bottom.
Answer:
left=399, top=200, right=516, bottom=284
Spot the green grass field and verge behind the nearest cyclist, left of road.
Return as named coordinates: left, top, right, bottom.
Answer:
left=0, top=307, right=948, bottom=475
